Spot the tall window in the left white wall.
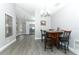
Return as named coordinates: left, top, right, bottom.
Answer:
left=5, top=14, right=12, bottom=37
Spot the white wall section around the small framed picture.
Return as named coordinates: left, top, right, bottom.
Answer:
left=35, top=10, right=51, bottom=39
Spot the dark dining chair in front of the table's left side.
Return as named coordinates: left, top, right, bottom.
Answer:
left=44, top=32, right=53, bottom=51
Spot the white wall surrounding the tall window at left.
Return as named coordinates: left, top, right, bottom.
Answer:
left=0, top=3, right=16, bottom=48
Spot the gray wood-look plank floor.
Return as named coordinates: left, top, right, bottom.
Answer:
left=0, top=35, right=74, bottom=55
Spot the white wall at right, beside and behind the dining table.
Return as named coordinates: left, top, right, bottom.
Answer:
left=51, top=0, right=79, bottom=54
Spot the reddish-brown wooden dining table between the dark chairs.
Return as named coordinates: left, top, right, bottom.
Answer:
left=47, top=31, right=63, bottom=47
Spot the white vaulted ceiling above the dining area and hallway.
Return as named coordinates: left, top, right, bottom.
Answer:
left=16, top=0, right=65, bottom=19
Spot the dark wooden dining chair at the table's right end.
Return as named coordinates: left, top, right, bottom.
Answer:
left=59, top=31, right=71, bottom=53
